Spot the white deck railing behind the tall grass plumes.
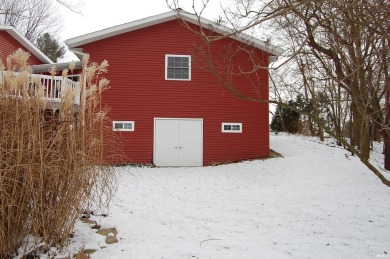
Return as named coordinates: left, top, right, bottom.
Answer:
left=0, top=72, right=80, bottom=105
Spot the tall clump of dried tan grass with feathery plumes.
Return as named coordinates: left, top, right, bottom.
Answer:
left=0, top=50, right=115, bottom=258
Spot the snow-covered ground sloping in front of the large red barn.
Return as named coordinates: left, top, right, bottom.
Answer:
left=53, top=134, right=390, bottom=259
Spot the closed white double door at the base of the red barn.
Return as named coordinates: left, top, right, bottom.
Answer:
left=153, top=118, right=203, bottom=166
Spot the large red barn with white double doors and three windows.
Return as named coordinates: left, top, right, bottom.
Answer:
left=66, top=12, right=281, bottom=166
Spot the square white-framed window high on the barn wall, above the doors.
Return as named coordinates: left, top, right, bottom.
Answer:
left=165, top=54, right=191, bottom=81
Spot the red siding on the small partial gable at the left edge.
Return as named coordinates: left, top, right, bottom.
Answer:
left=0, top=31, right=42, bottom=65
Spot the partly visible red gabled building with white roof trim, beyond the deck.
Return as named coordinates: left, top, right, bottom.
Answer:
left=0, top=25, right=53, bottom=65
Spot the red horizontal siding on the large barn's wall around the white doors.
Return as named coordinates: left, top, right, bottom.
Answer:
left=82, top=21, right=269, bottom=165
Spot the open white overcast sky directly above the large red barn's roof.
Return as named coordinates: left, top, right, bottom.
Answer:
left=59, top=0, right=226, bottom=61
